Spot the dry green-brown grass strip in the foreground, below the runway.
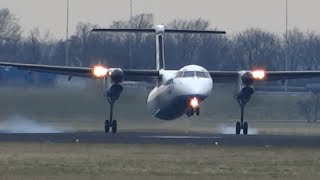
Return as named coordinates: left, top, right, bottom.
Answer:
left=0, top=143, right=320, bottom=180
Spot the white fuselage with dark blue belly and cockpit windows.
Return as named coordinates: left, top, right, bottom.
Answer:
left=147, top=65, right=213, bottom=120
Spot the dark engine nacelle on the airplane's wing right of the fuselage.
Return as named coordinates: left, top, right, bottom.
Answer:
left=236, top=71, right=254, bottom=100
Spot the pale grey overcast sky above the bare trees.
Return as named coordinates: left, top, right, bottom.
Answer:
left=0, top=0, right=320, bottom=38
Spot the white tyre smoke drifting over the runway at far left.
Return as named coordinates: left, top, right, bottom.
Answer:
left=0, top=115, right=70, bottom=133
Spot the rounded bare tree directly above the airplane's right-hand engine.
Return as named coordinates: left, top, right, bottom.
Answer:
left=232, top=29, right=284, bottom=70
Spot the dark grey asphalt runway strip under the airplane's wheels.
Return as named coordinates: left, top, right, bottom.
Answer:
left=0, top=132, right=320, bottom=147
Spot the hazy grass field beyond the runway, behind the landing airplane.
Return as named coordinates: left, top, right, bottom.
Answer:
left=0, top=81, right=320, bottom=134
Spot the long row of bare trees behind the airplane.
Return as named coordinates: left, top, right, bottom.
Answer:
left=0, top=9, right=320, bottom=70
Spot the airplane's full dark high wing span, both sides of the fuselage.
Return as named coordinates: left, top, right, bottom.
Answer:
left=0, top=62, right=320, bottom=83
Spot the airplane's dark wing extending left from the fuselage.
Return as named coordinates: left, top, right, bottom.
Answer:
left=0, top=62, right=159, bottom=81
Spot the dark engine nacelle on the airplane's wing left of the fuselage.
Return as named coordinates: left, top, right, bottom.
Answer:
left=104, top=69, right=124, bottom=101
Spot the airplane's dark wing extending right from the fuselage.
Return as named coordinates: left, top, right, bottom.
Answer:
left=209, top=71, right=320, bottom=83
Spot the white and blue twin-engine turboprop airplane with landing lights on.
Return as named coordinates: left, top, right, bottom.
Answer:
left=0, top=25, right=320, bottom=134
